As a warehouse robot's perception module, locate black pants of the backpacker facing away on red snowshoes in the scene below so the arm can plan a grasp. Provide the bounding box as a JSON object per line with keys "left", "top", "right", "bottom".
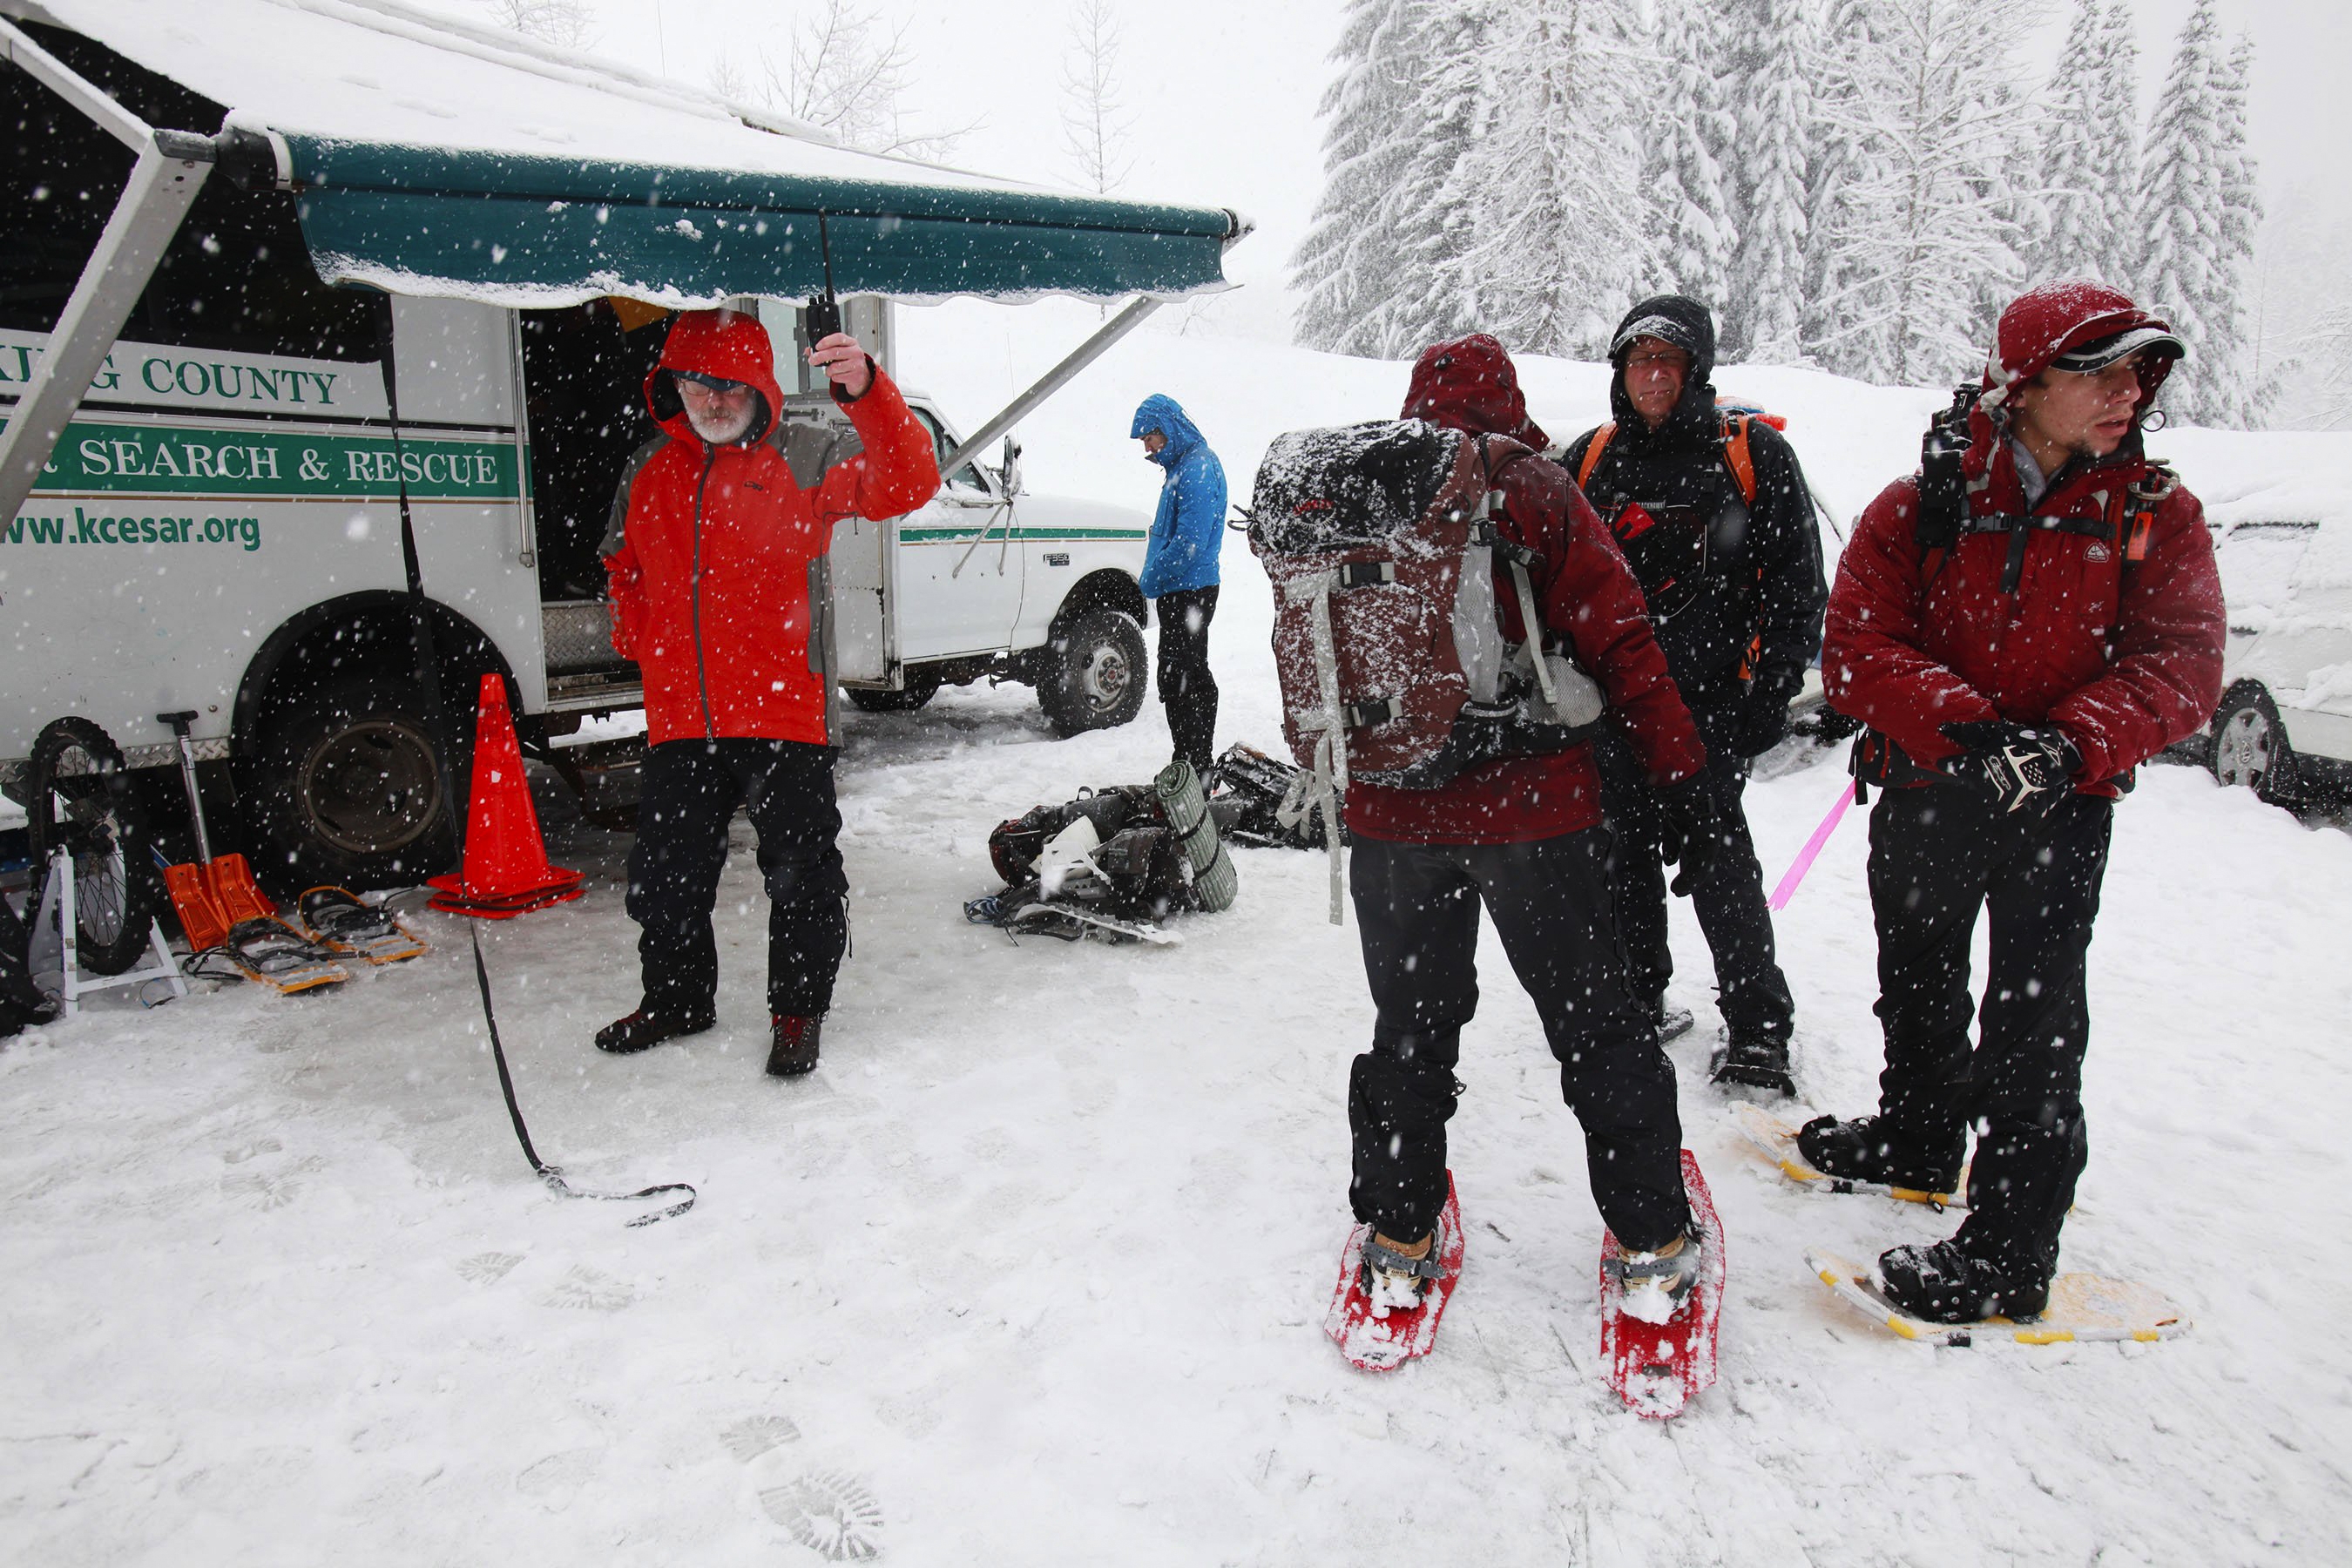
{"left": 1348, "top": 828, "right": 1689, "bottom": 1251}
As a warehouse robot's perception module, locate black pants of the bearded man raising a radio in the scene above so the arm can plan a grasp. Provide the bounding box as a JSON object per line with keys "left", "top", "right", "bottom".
{"left": 628, "top": 740, "right": 849, "bottom": 1016}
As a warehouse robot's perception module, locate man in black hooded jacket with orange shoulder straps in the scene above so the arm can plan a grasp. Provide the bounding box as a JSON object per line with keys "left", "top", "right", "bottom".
{"left": 1562, "top": 294, "right": 1830, "bottom": 1096}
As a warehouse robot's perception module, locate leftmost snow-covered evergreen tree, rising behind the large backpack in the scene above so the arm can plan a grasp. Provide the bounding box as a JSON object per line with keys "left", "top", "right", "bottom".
{"left": 1291, "top": 0, "right": 1421, "bottom": 355}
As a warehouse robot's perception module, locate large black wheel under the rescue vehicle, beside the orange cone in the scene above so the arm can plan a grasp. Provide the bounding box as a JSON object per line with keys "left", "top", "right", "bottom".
{"left": 252, "top": 679, "right": 473, "bottom": 889}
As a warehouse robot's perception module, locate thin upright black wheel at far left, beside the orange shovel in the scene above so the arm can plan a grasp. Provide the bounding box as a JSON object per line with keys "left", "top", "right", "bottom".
{"left": 24, "top": 717, "right": 162, "bottom": 976}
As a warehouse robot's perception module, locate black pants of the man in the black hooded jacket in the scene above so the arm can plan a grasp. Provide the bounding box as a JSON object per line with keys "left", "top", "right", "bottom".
{"left": 1592, "top": 710, "right": 1797, "bottom": 1044}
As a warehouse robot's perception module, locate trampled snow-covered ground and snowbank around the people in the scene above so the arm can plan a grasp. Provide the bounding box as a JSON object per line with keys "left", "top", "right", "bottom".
{"left": 0, "top": 308, "right": 2352, "bottom": 1568}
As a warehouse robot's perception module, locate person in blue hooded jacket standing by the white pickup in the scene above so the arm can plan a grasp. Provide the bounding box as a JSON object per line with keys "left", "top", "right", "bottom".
{"left": 1129, "top": 393, "right": 1226, "bottom": 776}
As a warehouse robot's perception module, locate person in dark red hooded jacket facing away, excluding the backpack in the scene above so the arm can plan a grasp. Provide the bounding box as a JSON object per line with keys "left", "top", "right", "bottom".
{"left": 1348, "top": 334, "right": 1706, "bottom": 1312}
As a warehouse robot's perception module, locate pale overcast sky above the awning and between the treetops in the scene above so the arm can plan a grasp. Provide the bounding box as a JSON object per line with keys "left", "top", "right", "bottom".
{"left": 449, "top": 0, "right": 2352, "bottom": 336}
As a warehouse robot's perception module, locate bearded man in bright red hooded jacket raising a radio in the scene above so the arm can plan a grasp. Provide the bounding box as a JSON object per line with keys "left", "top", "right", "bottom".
{"left": 595, "top": 310, "right": 938, "bottom": 1077}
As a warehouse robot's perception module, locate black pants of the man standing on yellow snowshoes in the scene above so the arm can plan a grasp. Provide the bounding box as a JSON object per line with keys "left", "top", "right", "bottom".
{"left": 1870, "top": 783, "right": 2114, "bottom": 1281}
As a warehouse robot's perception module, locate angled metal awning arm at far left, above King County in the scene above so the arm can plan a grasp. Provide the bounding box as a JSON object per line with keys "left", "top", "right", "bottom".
{"left": 0, "top": 21, "right": 212, "bottom": 522}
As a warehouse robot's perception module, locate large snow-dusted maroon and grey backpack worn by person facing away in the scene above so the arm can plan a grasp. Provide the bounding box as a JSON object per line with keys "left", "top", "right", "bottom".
{"left": 1244, "top": 418, "right": 1602, "bottom": 922}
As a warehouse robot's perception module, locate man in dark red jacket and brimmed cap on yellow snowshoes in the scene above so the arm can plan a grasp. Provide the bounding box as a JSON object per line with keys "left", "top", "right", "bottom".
{"left": 1797, "top": 282, "right": 2225, "bottom": 1323}
